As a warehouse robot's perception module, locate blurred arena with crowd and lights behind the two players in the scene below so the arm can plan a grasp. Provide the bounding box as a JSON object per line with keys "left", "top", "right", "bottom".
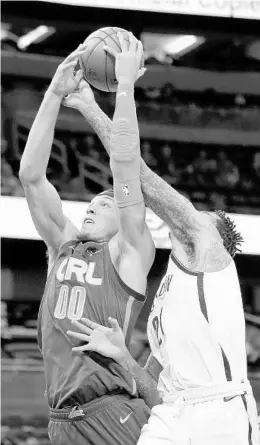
{"left": 1, "top": 0, "right": 260, "bottom": 445}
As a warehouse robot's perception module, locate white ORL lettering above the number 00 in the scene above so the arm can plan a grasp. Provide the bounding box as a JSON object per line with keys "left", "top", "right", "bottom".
{"left": 56, "top": 257, "right": 102, "bottom": 286}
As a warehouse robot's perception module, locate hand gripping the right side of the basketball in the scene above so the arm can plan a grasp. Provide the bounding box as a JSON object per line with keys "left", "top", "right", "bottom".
{"left": 104, "top": 32, "right": 146, "bottom": 83}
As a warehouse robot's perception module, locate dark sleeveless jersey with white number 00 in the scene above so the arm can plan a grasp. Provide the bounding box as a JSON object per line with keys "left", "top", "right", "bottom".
{"left": 38, "top": 241, "right": 145, "bottom": 408}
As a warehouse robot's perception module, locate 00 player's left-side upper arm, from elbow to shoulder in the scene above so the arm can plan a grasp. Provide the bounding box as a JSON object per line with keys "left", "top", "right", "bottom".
{"left": 23, "top": 177, "right": 77, "bottom": 251}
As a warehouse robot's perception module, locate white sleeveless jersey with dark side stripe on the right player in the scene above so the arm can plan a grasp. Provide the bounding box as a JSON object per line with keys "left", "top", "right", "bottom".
{"left": 148, "top": 254, "right": 247, "bottom": 395}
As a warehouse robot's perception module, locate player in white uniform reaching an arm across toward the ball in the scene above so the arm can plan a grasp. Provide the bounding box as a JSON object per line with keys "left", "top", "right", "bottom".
{"left": 66, "top": 40, "right": 259, "bottom": 445}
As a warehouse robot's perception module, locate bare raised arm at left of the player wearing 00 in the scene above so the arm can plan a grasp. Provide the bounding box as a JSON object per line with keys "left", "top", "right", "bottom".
{"left": 19, "top": 45, "right": 85, "bottom": 260}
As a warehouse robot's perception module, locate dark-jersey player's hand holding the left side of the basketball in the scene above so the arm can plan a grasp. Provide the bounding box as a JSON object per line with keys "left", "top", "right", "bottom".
{"left": 48, "top": 44, "right": 87, "bottom": 97}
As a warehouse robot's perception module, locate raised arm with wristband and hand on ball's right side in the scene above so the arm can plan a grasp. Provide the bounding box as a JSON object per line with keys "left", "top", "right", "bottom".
{"left": 105, "top": 33, "right": 154, "bottom": 278}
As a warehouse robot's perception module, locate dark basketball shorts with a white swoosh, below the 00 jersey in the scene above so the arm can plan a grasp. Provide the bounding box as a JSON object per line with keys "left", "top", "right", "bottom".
{"left": 49, "top": 395, "right": 151, "bottom": 445}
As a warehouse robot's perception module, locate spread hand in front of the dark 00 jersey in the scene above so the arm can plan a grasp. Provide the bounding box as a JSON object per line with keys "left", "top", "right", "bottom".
{"left": 67, "top": 317, "right": 127, "bottom": 361}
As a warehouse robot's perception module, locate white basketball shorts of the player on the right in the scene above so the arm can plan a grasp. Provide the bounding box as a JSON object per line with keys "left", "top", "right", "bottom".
{"left": 137, "top": 396, "right": 259, "bottom": 445}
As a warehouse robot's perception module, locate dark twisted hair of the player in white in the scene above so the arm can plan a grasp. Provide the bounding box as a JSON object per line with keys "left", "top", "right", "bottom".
{"left": 214, "top": 210, "right": 244, "bottom": 258}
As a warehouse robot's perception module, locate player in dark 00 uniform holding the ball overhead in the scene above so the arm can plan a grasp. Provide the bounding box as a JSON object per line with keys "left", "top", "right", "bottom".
{"left": 18, "top": 37, "right": 158, "bottom": 445}
